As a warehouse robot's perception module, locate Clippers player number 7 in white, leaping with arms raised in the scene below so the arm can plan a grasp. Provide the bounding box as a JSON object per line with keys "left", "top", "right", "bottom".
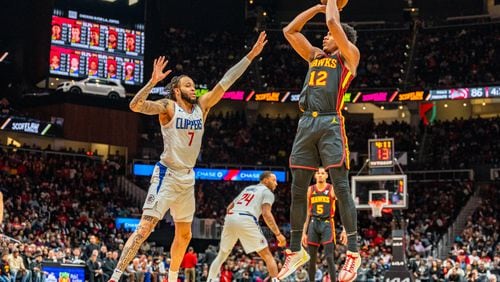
{"left": 110, "top": 32, "right": 267, "bottom": 282}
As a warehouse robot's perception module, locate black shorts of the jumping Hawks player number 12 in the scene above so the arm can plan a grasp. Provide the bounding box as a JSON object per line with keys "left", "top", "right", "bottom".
{"left": 290, "top": 114, "right": 349, "bottom": 170}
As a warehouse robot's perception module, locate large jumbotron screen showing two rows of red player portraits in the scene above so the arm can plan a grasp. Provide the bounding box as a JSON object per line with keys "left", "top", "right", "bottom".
{"left": 49, "top": 10, "right": 144, "bottom": 85}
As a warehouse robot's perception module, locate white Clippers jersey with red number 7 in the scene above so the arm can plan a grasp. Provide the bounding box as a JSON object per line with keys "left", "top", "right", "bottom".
{"left": 160, "top": 102, "right": 204, "bottom": 169}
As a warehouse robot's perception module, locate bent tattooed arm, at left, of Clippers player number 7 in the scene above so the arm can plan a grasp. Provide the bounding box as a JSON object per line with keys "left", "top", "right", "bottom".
{"left": 129, "top": 56, "right": 172, "bottom": 115}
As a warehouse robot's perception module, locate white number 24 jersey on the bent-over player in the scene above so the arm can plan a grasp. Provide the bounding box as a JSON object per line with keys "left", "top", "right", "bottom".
{"left": 233, "top": 183, "right": 274, "bottom": 219}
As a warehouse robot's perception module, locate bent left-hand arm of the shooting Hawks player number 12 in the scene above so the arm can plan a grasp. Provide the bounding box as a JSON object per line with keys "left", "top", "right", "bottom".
{"left": 283, "top": 5, "right": 325, "bottom": 62}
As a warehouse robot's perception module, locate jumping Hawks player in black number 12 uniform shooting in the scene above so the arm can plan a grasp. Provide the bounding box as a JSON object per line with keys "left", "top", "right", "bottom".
{"left": 279, "top": 0, "right": 361, "bottom": 281}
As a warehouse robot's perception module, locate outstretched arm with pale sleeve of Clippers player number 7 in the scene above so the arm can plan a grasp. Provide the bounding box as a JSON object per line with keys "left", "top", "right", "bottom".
{"left": 199, "top": 31, "right": 267, "bottom": 112}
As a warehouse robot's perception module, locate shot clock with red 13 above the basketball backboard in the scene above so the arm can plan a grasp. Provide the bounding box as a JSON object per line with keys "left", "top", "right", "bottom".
{"left": 368, "top": 138, "right": 394, "bottom": 168}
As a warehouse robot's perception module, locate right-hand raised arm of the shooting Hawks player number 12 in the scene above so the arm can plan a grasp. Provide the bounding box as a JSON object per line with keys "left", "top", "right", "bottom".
{"left": 326, "top": 0, "right": 360, "bottom": 75}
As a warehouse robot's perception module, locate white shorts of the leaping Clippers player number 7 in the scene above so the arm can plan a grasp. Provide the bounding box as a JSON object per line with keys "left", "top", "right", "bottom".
{"left": 143, "top": 162, "right": 195, "bottom": 222}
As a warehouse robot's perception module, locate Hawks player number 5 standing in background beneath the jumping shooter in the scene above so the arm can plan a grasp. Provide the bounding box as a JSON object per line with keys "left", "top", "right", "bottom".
{"left": 302, "top": 167, "right": 347, "bottom": 281}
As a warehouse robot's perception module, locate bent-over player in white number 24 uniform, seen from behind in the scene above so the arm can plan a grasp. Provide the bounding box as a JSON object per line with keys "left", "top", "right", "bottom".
{"left": 208, "top": 171, "right": 286, "bottom": 282}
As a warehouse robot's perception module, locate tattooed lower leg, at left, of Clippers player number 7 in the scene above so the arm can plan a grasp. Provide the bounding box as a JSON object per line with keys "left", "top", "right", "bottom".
{"left": 116, "top": 215, "right": 158, "bottom": 272}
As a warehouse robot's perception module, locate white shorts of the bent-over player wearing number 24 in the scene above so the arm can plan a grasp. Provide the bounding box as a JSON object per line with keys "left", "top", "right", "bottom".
{"left": 220, "top": 211, "right": 267, "bottom": 254}
